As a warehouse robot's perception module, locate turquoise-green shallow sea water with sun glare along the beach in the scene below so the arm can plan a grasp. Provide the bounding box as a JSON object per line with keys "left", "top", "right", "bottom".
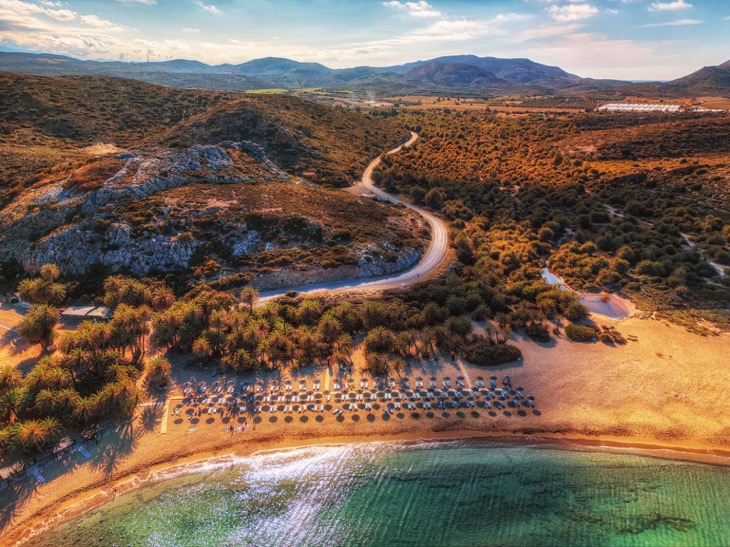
{"left": 31, "top": 441, "right": 730, "bottom": 547}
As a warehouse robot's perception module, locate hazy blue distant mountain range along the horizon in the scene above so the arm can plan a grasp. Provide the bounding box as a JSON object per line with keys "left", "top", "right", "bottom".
{"left": 0, "top": 52, "right": 730, "bottom": 98}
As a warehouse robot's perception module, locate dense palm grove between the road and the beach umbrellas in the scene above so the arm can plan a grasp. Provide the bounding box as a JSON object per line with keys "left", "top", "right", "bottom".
{"left": 0, "top": 256, "right": 540, "bottom": 450}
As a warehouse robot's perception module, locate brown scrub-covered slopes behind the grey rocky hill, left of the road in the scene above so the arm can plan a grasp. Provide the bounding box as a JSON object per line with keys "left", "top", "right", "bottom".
{"left": 0, "top": 73, "right": 408, "bottom": 200}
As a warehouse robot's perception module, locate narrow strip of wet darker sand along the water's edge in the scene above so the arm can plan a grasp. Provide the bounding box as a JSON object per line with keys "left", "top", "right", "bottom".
{"left": 8, "top": 429, "right": 730, "bottom": 545}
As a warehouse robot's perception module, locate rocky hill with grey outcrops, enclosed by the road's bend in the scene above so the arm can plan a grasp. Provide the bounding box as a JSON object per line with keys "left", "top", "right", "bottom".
{"left": 0, "top": 141, "right": 427, "bottom": 292}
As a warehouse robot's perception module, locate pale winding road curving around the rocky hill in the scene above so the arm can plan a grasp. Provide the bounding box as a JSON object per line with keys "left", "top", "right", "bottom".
{"left": 259, "top": 131, "right": 449, "bottom": 303}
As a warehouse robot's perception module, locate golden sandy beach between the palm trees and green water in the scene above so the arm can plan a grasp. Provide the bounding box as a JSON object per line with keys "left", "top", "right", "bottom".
{"left": 0, "top": 310, "right": 730, "bottom": 544}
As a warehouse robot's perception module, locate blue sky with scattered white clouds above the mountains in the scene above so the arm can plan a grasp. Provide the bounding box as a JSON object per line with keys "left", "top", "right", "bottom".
{"left": 0, "top": 0, "right": 730, "bottom": 80}
